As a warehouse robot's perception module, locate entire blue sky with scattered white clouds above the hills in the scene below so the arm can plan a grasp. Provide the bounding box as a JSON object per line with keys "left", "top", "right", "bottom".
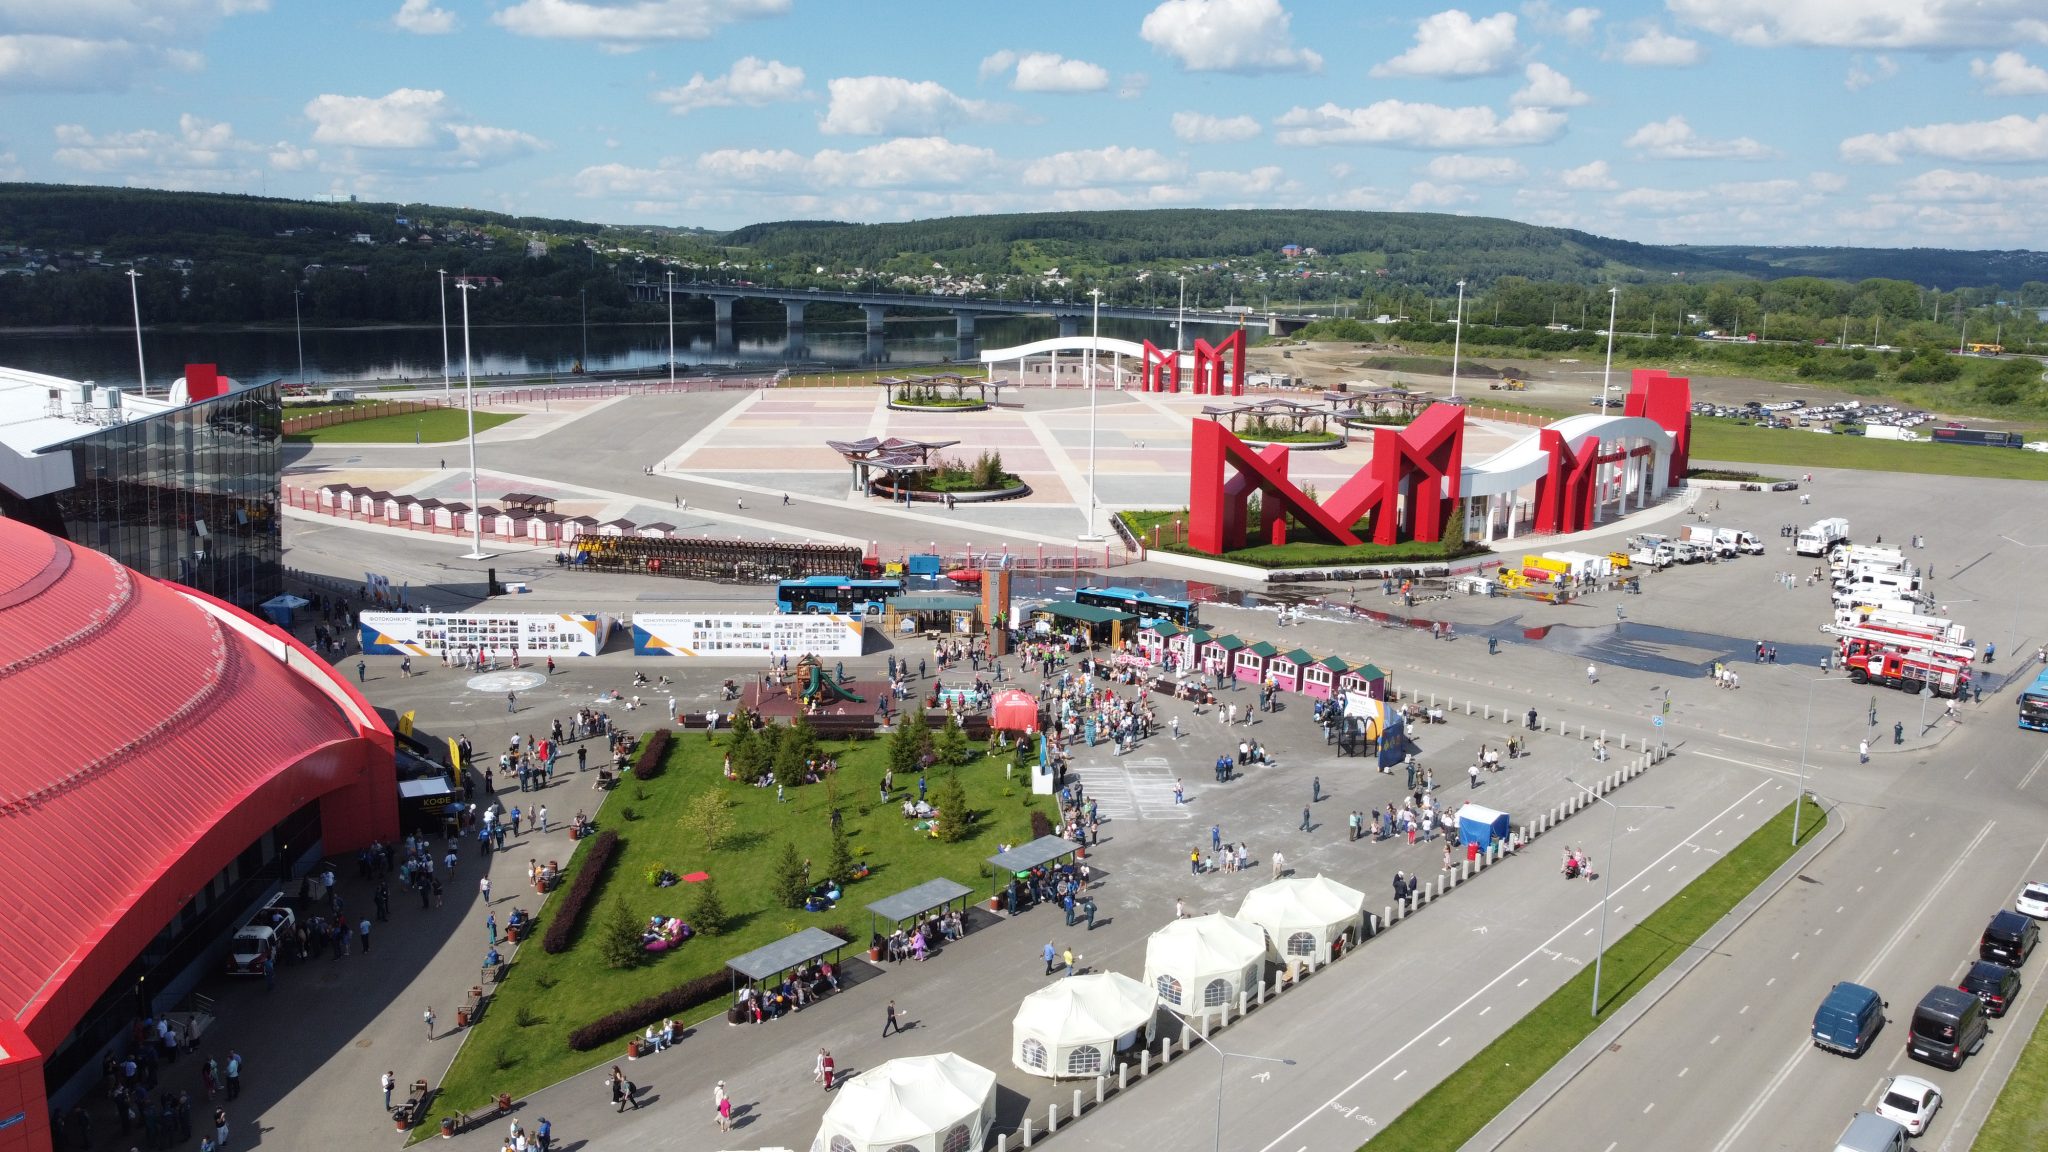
{"left": 0, "top": 0, "right": 2048, "bottom": 248}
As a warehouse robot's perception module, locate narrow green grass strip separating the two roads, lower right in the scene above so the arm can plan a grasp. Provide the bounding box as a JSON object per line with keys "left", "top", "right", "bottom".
{"left": 1366, "top": 787, "right": 1826, "bottom": 1152}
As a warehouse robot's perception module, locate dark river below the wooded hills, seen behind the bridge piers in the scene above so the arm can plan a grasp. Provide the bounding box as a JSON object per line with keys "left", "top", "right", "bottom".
{"left": 0, "top": 316, "right": 1212, "bottom": 387}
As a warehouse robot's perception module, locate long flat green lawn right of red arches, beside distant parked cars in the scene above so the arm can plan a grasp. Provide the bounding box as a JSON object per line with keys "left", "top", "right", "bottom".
{"left": 1692, "top": 418, "right": 2048, "bottom": 480}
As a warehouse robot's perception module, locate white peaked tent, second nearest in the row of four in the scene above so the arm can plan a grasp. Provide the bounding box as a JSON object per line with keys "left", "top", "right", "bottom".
{"left": 1010, "top": 972, "right": 1159, "bottom": 1080}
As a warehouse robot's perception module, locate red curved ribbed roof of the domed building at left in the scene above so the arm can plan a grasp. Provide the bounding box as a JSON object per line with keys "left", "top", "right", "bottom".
{"left": 0, "top": 519, "right": 377, "bottom": 1052}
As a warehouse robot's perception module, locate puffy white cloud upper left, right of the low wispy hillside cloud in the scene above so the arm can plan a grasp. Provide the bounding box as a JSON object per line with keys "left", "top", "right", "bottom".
{"left": 305, "top": 88, "right": 545, "bottom": 168}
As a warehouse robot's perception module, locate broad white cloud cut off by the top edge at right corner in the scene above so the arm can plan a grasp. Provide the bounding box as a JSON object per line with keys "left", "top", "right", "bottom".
{"left": 1665, "top": 0, "right": 2048, "bottom": 49}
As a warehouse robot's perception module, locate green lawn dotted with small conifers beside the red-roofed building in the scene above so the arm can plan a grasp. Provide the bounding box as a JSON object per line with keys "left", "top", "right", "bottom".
{"left": 416, "top": 721, "right": 1055, "bottom": 1136}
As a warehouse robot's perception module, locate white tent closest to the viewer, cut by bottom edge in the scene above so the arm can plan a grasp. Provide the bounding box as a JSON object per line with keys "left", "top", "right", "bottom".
{"left": 811, "top": 1052, "right": 995, "bottom": 1152}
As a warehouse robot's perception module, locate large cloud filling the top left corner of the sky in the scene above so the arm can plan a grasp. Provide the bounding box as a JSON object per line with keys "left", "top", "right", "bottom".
{"left": 0, "top": 0, "right": 268, "bottom": 92}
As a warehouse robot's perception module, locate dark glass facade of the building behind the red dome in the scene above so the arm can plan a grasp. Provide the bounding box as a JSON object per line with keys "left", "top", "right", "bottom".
{"left": 23, "top": 383, "right": 285, "bottom": 609}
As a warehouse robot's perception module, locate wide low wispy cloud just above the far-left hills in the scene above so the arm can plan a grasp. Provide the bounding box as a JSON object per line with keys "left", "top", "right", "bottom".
{"left": 49, "top": 113, "right": 313, "bottom": 189}
